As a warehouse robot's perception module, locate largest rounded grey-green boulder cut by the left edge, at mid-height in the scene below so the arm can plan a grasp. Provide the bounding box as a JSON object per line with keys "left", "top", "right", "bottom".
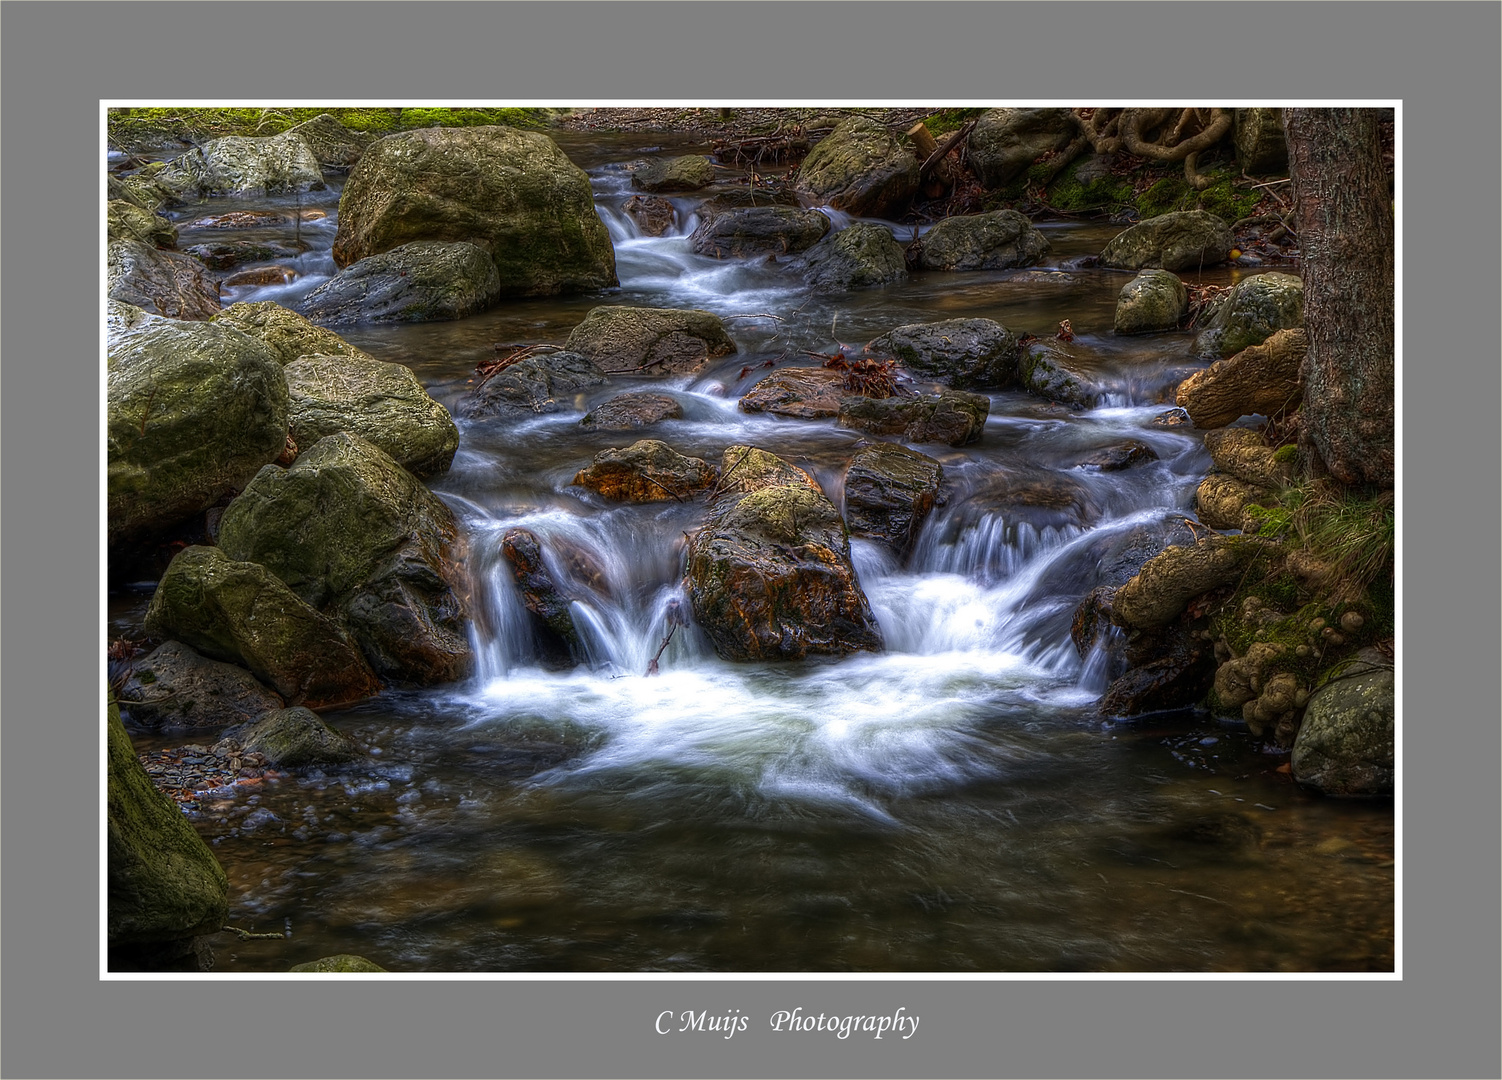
{"left": 105, "top": 318, "right": 288, "bottom": 547}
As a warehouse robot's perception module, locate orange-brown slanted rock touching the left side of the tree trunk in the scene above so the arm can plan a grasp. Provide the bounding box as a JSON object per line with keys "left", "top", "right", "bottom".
{"left": 1175, "top": 330, "right": 1308, "bottom": 428}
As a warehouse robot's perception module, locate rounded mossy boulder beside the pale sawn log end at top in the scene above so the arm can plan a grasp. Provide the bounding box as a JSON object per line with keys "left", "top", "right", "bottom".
{"left": 795, "top": 116, "right": 919, "bottom": 218}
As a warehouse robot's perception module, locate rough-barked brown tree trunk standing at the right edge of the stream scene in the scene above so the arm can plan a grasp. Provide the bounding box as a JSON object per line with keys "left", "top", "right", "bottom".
{"left": 1284, "top": 108, "right": 1395, "bottom": 488}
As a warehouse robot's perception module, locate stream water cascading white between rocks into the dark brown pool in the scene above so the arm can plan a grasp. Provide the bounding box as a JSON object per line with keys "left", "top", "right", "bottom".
{"left": 111, "top": 135, "right": 1395, "bottom": 972}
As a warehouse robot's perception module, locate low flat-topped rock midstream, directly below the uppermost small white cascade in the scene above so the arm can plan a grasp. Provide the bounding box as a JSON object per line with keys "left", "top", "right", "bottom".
{"left": 563, "top": 308, "right": 736, "bottom": 376}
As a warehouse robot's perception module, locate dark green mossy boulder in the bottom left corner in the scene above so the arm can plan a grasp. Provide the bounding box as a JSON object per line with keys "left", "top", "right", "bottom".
{"left": 105, "top": 701, "right": 230, "bottom": 948}
